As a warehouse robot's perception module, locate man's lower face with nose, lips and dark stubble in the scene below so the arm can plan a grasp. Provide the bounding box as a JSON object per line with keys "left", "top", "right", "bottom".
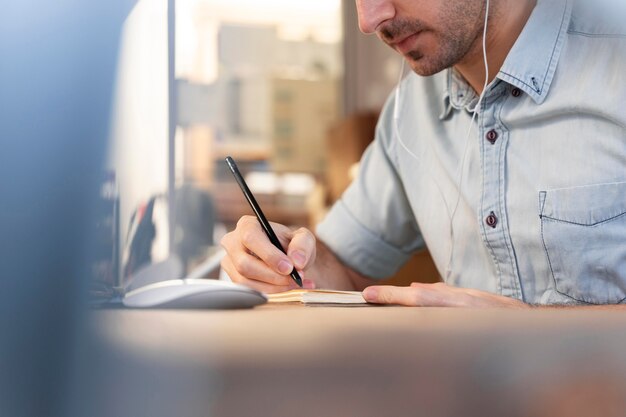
{"left": 356, "top": 0, "right": 485, "bottom": 76}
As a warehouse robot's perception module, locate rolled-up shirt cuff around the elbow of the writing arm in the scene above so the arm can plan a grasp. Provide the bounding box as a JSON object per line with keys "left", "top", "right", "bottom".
{"left": 316, "top": 200, "right": 411, "bottom": 279}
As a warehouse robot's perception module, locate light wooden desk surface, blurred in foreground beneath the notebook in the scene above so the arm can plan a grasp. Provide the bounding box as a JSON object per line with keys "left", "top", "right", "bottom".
{"left": 85, "top": 305, "right": 626, "bottom": 417}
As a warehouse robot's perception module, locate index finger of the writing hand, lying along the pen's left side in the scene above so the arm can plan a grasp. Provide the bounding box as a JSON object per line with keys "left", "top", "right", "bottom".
{"left": 233, "top": 216, "right": 293, "bottom": 275}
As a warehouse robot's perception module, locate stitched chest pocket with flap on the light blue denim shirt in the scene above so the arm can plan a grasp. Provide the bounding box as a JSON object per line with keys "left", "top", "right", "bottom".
{"left": 539, "top": 182, "right": 626, "bottom": 304}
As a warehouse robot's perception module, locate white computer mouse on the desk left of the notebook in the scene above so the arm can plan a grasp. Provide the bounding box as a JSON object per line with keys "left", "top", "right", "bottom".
{"left": 122, "top": 279, "right": 267, "bottom": 309}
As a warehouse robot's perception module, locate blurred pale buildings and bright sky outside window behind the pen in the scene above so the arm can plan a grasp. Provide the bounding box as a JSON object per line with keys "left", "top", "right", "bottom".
{"left": 175, "top": 0, "right": 343, "bottom": 270}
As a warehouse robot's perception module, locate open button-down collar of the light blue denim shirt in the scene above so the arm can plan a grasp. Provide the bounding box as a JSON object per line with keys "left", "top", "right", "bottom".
{"left": 441, "top": 0, "right": 572, "bottom": 109}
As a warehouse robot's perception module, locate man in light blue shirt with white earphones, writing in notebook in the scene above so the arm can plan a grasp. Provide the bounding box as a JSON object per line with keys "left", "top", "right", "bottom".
{"left": 222, "top": 0, "right": 626, "bottom": 308}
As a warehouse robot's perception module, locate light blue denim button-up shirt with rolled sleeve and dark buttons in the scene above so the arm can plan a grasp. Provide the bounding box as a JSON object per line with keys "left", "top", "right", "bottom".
{"left": 317, "top": 0, "right": 626, "bottom": 304}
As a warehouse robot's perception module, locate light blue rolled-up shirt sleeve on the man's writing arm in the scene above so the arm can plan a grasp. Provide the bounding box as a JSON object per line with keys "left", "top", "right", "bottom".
{"left": 316, "top": 92, "right": 425, "bottom": 279}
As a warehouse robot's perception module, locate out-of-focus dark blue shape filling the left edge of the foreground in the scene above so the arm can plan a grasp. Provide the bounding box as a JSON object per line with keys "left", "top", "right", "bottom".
{"left": 0, "top": 0, "right": 128, "bottom": 417}
